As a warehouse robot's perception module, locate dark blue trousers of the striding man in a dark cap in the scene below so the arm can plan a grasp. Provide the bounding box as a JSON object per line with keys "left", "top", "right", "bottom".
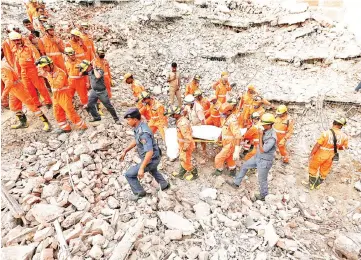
{"left": 125, "top": 157, "right": 168, "bottom": 194}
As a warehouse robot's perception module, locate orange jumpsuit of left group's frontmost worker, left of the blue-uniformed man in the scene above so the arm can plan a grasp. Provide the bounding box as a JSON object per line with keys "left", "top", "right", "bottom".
{"left": 42, "top": 66, "right": 87, "bottom": 130}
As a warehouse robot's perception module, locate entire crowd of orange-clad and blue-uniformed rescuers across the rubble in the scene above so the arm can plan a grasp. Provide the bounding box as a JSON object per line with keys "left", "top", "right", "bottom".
{"left": 1, "top": 0, "right": 348, "bottom": 199}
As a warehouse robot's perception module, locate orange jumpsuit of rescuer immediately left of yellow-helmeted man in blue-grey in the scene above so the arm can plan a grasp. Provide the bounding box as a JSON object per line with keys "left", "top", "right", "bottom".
{"left": 215, "top": 114, "right": 242, "bottom": 170}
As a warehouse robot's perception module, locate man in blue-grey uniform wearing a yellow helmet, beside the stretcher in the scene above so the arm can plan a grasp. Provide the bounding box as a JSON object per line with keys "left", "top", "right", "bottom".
{"left": 226, "top": 113, "right": 277, "bottom": 200}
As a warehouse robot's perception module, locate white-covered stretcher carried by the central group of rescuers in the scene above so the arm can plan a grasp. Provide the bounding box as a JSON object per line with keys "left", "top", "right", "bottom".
{"left": 165, "top": 125, "right": 247, "bottom": 160}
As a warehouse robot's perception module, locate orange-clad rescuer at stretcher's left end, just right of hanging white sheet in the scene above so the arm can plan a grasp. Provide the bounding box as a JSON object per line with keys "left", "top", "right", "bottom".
{"left": 166, "top": 106, "right": 198, "bottom": 181}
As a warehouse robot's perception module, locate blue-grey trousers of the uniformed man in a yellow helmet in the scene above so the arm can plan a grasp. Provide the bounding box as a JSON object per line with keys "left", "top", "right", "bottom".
{"left": 234, "top": 156, "right": 273, "bottom": 197}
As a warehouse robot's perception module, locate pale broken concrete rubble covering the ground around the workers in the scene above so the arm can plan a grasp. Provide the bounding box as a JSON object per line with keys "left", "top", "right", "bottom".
{"left": 1, "top": 0, "right": 361, "bottom": 260}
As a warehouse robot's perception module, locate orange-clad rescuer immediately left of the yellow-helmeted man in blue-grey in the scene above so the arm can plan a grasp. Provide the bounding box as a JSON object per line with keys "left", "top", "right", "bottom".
{"left": 213, "top": 102, "right": 242, "bottom": 176}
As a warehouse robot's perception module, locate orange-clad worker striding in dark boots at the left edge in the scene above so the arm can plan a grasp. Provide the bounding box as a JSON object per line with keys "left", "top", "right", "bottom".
{"left": 1, "top": 49, "right": 50, "bottom": 131}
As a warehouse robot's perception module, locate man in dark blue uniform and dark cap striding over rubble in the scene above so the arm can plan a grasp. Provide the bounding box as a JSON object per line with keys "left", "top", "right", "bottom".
{"left": 120, "top": 108, "right": 169, "bottom": 201}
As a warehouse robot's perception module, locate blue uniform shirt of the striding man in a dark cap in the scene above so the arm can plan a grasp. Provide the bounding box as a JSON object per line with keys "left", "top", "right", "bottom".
{"left": 134, "top": 122, "right": 160, "bottom": 161}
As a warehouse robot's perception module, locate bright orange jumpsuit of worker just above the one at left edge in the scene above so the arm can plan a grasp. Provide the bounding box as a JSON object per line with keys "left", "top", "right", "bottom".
{"left": 15, "top": 45, "right": 52, "bottom": 106}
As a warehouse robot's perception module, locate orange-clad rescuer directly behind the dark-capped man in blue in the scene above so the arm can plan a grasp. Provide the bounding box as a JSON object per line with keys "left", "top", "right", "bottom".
{"left": 139, "top": 91, "right": 168, "bottom": 142}
